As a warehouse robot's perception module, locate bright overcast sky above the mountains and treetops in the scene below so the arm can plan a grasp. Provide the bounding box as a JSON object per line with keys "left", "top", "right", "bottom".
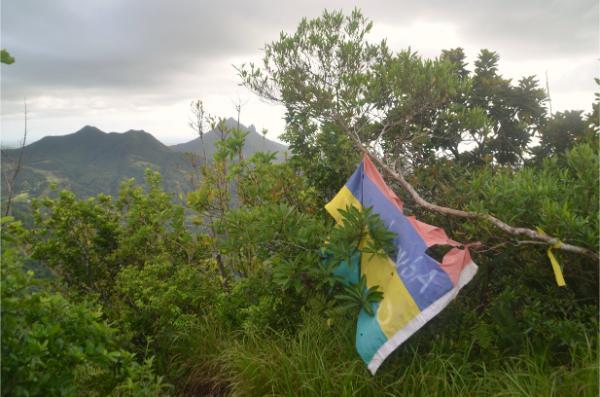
{"left": 0, "top": 0, "right": 599, "bottom": 144}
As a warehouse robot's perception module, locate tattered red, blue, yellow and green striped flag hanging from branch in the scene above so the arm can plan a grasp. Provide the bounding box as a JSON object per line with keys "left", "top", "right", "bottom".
{"left": 325, "top": 155, "right": 477, "bottom": 374}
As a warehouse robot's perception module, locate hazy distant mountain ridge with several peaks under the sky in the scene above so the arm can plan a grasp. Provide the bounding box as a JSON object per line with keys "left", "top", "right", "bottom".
{"left": 1, "top": 119, "right": 287, "bottom": 210}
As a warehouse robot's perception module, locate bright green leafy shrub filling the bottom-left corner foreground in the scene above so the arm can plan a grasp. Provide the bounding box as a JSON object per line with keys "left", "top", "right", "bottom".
{"left": 2, "top": 232, "right": 168, "bottom": 396}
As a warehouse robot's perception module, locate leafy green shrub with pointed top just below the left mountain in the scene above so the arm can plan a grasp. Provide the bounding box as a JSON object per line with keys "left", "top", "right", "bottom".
{"left": 31, "top": 170, "right": 206, "bottom": 299}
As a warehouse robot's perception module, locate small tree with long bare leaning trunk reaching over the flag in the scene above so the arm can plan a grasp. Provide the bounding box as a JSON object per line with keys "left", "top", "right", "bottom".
{"left": 238, "top": 10, "right": 597, "bottom": 258}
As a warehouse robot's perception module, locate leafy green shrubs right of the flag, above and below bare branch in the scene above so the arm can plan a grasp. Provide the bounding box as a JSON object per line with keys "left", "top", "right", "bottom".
{"left": 404, "top": 144, "right": 599, "bottom": 374}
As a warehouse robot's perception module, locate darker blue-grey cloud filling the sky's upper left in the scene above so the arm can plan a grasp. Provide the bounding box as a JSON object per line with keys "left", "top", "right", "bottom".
{"left": 2, "top": 0, "right": 264, "bottom": 91}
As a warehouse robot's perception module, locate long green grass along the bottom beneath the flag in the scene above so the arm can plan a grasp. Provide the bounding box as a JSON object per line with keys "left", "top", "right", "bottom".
{"left": 179, "top": 313, "right": 598, "bottom": 397}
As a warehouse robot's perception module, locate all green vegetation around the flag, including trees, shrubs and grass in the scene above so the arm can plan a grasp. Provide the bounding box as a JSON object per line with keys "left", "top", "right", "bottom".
{"left": 2, "top": 12, "right": 599, "bottom": 396}
